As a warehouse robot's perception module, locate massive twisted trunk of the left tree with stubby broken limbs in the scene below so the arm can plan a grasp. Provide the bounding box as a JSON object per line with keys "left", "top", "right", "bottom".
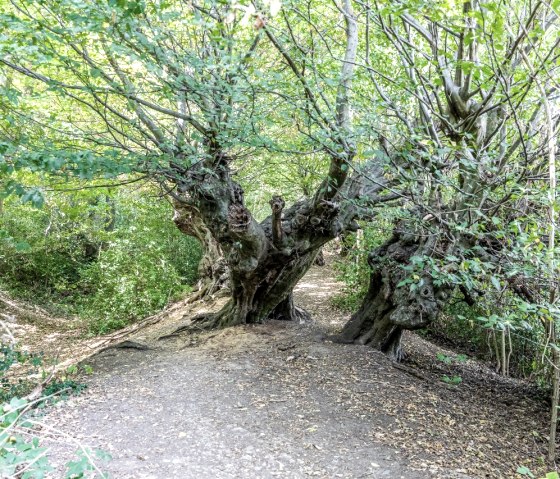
{"left": 176, "top": 152, "right": 358, "bottom": 330}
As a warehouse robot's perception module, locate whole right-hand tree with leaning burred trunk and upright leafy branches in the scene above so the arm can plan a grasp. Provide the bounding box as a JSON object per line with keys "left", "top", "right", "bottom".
{"left": 338, "top": 1, "right": 558, "bottom": 358}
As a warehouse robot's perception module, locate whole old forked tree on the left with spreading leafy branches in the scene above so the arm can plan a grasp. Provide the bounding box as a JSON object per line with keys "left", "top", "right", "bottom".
{"left": 0, "top": 0, "right": 374, "bottom": 327}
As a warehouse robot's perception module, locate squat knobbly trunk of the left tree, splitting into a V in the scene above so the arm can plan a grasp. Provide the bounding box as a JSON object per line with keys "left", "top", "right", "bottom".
{"left": 186, "top": 182, "right": 353, "bottom": 328}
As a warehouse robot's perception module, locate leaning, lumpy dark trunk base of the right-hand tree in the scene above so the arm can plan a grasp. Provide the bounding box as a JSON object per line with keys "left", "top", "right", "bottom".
{"left": 334, "top": 224, "right": 447, "bottom": 360}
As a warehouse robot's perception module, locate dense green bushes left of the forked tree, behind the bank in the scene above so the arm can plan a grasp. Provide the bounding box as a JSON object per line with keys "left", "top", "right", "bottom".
{"left": 0, "top": 182, "right": 201, "bottom": 334}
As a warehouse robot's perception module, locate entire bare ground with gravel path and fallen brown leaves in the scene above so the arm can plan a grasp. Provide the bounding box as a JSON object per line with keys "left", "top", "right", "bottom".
{"left": 3, "top": 260, "right": 553, "bottom": 479}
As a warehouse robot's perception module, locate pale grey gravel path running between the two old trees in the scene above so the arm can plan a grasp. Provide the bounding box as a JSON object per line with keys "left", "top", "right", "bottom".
{"left": 40, "top": 269, "right": 434, "bottom": 479}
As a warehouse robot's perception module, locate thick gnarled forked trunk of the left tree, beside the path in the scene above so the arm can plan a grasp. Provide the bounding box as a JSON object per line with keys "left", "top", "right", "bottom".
{"left": 174, "top": 180, "right": 328, "bottom": 329}
